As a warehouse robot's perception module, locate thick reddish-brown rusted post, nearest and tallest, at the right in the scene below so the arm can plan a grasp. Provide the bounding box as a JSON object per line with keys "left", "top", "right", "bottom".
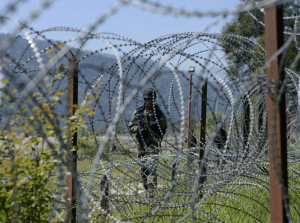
{"left": 265, "top": 0, "right": 288, "bottom": 223}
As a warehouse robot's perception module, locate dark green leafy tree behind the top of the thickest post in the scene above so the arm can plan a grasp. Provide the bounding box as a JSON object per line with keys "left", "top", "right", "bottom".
{"left": 222, "top": 0, "right": 300, "bottom": 75}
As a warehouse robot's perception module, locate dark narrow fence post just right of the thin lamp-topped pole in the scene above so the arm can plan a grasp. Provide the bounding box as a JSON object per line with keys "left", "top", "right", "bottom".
{"left": 199, "top": 78, "right": 208, "bottom": 198}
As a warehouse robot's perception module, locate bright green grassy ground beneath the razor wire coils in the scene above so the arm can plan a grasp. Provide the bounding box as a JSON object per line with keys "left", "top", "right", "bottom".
{"left": 73, "top": 133, "right": 300, "bottom": 223}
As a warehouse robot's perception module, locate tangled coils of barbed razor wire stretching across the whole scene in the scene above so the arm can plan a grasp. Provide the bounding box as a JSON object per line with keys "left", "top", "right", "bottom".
{"left": 0, "top": 0, "right": 300, "bottom": 222}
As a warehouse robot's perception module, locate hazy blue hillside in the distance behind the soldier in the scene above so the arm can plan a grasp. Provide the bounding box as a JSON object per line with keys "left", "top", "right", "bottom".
{"left": 0, "top": 34, "right": 226, "bottom": 129}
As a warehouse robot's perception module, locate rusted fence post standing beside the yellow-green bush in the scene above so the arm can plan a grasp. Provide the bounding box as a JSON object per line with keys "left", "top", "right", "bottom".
{"left": 67, "top": 51, "right": 78, "bottom": 223}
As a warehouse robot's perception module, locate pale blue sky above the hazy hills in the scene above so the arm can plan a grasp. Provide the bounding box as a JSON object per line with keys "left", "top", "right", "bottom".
{"left": 0, "top": 0, "right": 240, "bottom": 49}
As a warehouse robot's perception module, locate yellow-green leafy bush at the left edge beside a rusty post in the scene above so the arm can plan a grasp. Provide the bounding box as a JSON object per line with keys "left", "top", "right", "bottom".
{"left": 0, "top": 52, "right": 93, "bottom": 222}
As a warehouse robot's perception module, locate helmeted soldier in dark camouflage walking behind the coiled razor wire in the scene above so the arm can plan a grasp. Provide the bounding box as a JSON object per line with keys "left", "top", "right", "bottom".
{"left": 128, "top": 88, "right": 167, "bottom": 198}
